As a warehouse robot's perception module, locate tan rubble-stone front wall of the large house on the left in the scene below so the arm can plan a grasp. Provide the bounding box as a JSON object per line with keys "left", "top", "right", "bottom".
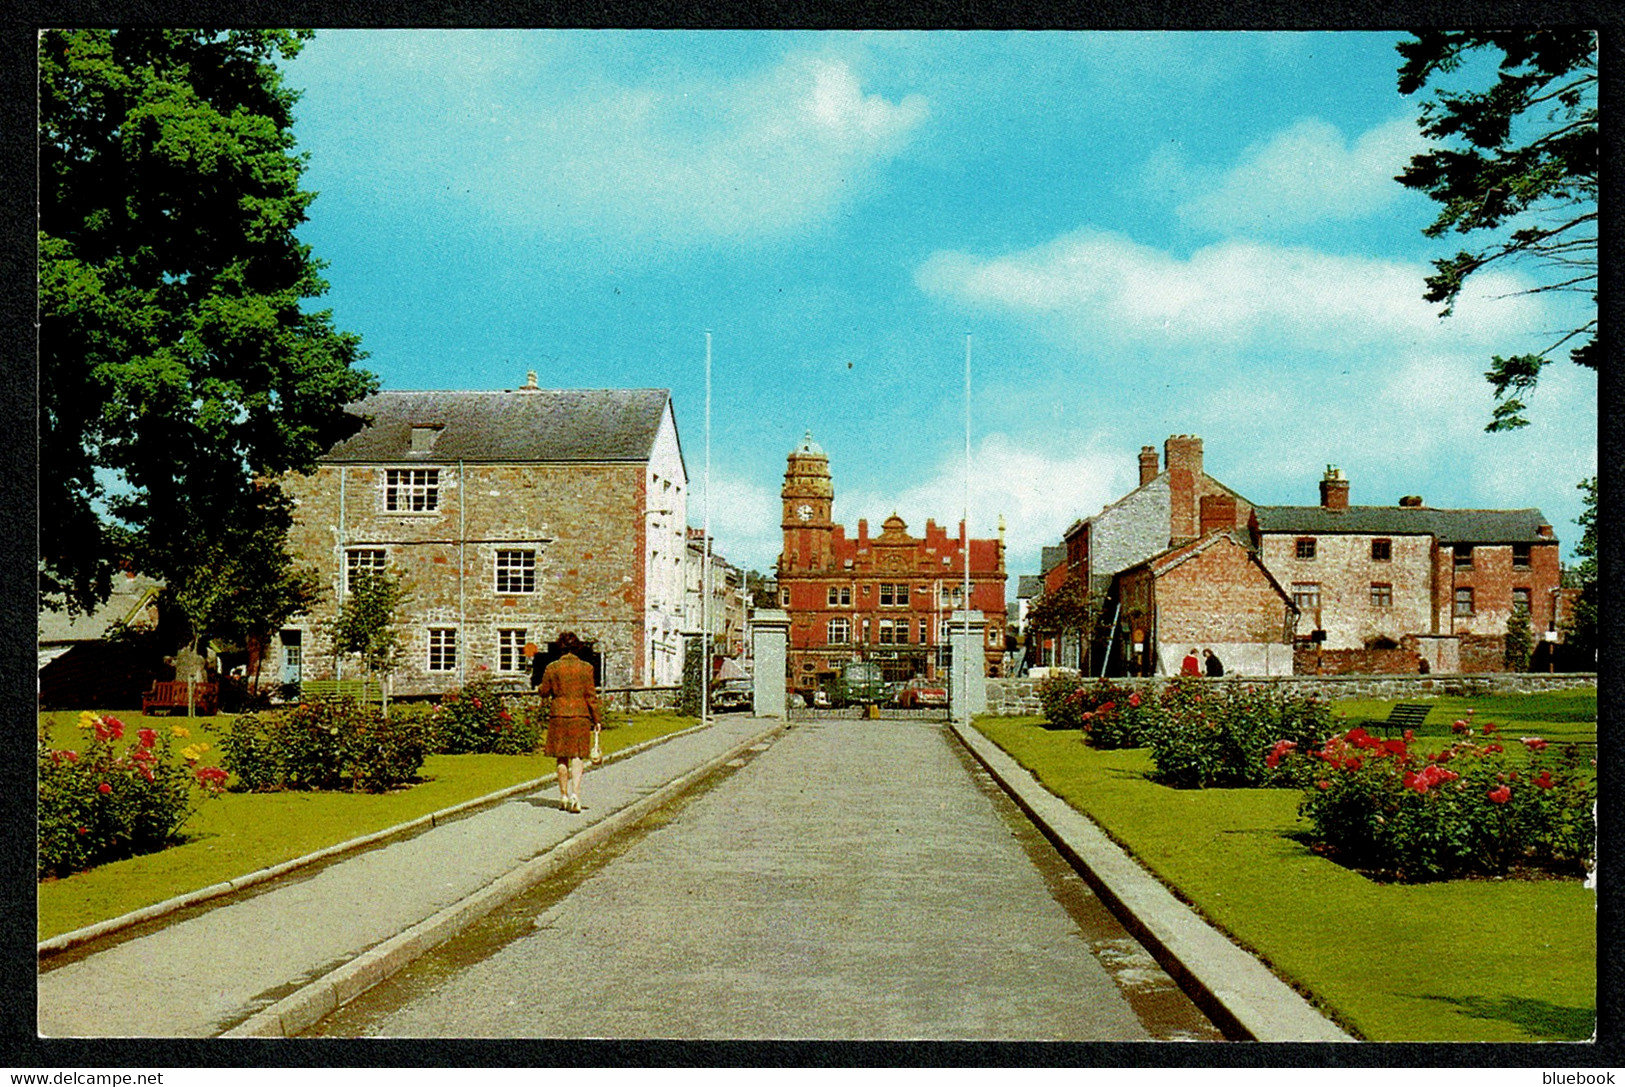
{"left": 282, "top": 463, "right": 647, "bottom": 695}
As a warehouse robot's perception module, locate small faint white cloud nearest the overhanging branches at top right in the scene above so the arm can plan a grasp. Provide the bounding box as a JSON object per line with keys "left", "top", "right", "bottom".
{"left": 1176, "top": 119, "right": 1425, "bottom": 234}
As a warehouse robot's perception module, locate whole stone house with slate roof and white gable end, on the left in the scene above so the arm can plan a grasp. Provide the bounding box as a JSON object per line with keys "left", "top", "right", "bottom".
{"left": 270, "top": 374, "right": 687, "bottom": 695}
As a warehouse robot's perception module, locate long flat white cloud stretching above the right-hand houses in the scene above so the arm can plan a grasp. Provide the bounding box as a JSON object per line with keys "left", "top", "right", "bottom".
{"left": 915, "top": 227, "right": 1537, "bottom": 353}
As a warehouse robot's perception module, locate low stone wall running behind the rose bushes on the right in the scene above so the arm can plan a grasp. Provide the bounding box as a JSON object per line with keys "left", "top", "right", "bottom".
{"left": 988, "top": 673, "right": 1597, "bottom": 717}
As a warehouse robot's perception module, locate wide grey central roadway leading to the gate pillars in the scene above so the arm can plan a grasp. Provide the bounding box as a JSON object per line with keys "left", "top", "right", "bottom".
{"left": 319, "top": 720, "right": 1217, "bottom": 1040}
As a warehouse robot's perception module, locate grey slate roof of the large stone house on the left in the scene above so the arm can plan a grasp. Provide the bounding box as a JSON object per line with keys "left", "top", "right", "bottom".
{"left": 322, "top": 388, "right": 671, "bottom": 465}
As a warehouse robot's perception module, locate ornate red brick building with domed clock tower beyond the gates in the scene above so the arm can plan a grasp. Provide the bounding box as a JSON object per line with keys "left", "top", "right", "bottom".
{"left": 778, "top": 434, "right": 1004, "bottom": 695}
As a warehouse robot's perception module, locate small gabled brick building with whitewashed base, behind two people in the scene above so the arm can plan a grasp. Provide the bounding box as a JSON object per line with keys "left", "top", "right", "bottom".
{"left": 1108, "top": 531, "right": 1297, "bottom": 676}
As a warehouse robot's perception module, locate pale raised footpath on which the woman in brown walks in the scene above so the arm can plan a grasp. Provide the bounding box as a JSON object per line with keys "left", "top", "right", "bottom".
{"left": 39, "top": 715, "right": 775, "bottom": 1037}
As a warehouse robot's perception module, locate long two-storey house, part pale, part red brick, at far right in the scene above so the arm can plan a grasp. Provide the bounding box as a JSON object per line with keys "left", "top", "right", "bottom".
{"left": 1251, "top": 468, "right": 1562, "bottom": 673}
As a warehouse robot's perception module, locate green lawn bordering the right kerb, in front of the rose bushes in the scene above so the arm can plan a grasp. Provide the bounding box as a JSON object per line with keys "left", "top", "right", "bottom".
{"left": 977, "top": 708, "right": 1597, "bottom": 1042}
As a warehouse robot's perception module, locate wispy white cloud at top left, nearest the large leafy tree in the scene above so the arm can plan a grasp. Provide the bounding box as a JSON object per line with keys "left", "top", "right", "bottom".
{"left": 483, "top": 57, "right": 928, "bottom": 245}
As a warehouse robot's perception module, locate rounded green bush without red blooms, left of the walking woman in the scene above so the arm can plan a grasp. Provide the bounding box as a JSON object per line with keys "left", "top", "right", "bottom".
{"left": 221, "top": 699, "right": 432, "bottom": 793}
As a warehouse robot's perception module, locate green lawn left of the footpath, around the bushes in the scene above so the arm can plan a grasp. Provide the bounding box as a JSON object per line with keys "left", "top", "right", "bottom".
{"left": 37, "top": 713, "right": 697, "bottom": 939}
